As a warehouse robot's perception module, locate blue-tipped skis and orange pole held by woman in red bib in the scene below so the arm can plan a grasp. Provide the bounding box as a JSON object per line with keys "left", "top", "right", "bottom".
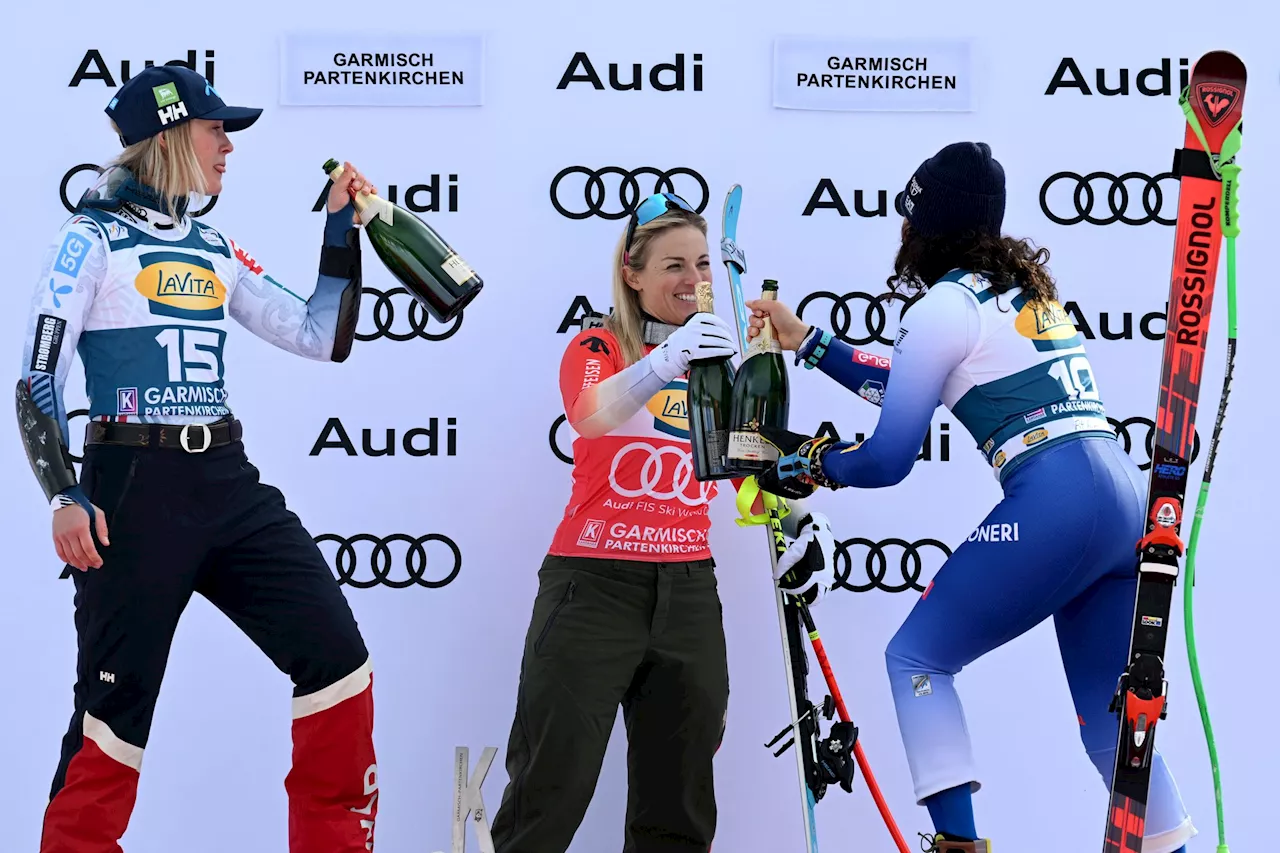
{"left": 721, "top": 184, "right": 909, "bottom": 853}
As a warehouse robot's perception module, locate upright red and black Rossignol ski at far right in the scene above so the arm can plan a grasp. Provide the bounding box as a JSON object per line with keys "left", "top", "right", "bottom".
{"left": 1102, "top": 51, "right": 1245, "bottom": 853}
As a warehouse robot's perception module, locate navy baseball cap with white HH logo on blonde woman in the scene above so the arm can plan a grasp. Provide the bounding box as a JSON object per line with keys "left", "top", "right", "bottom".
{"left": 104, "top": 65, "right": 262, "bottom": 146}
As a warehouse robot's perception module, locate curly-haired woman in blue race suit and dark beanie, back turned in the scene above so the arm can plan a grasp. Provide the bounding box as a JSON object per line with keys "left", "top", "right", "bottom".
{"left": 751, "top": 142, "right": 1196, "bottom": 853}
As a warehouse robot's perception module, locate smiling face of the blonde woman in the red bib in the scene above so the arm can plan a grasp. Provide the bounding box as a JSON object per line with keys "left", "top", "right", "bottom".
{"left": 623, "top": 225, "right": 712, "bottom": 325}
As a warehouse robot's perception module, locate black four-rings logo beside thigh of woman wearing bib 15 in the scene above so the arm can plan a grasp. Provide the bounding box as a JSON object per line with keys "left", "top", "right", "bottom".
{"left": 315, "top": 533, "right": 462, "bottom": 589}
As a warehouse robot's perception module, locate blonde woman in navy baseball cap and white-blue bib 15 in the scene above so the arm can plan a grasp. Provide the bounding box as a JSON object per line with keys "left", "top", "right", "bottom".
{"left": 10, "top": 65, "right": 378, "bottom": 853}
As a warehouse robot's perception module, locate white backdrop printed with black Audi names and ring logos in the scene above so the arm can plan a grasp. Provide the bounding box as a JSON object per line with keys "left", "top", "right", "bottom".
{"left": 0, "top": 0, "right": 1280, "bottom": 853}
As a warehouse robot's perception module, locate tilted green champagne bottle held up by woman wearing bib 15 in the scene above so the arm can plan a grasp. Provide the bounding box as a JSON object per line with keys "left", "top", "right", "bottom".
{"left": 324, "top": 159, "right": 484, "bottom": 323}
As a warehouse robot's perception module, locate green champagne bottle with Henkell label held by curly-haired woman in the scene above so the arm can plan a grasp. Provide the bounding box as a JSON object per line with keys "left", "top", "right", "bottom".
{"left": 728, "top": 278, "right": 791, "bottom": 476}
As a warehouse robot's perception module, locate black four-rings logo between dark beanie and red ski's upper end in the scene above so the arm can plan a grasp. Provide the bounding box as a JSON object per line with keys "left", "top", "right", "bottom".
{"left": 1041, "top": 172, "right": 1178, "bottom": 225}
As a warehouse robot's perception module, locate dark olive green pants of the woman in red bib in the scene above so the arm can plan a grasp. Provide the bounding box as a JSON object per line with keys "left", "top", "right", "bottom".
{"left": 492, "top": 556, "right": 728, "bottom": 853}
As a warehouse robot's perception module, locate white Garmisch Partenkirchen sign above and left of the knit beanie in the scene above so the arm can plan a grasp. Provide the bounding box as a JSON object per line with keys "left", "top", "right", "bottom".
{"left": 773, "top": 36, "right": 973, "bottom": 111}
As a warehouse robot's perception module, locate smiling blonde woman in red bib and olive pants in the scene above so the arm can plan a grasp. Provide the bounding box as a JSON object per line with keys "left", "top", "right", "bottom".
{"left": 492, "top": 193, "right": 835, "bottom": 853}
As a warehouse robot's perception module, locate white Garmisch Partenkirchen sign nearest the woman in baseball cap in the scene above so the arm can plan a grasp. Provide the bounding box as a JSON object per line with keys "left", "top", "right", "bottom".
{"left": 280, "top": 32, "right": 484, "bottom": 106}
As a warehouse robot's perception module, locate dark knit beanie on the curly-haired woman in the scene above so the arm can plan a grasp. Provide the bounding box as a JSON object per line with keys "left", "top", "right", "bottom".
{"left": 893, "top": 142, "right": 1005, "bottom": 237}
